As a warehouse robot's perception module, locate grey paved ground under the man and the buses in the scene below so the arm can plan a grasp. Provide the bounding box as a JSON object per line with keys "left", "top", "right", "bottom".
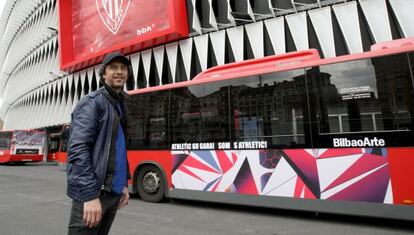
{"left": 0, "top": 163, "right": 414, "bottom": 235}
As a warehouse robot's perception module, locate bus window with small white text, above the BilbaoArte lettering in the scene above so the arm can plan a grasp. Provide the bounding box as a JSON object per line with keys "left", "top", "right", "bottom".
{"left": 309, "top": 54, "right": 414, "bottom": 145}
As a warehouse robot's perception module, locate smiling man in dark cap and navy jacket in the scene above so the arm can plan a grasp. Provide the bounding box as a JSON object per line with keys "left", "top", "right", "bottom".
{"left": 67, "top": 52, "right": 132, "bottom": 235}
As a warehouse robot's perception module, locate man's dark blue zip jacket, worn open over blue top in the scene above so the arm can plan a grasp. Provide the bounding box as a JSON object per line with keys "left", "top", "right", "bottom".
{"left": 67, "top": 87, "right": 129, "bottom": 202}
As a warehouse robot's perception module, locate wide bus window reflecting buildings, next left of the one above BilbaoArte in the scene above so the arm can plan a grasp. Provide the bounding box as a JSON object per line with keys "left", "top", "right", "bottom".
{"left": 231, "top": 70, "right": 310, "bottom": 147}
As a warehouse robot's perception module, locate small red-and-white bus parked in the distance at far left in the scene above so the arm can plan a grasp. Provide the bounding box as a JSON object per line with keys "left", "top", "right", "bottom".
{"left": 0, "top": 130, "right": 46, "bottom": 164}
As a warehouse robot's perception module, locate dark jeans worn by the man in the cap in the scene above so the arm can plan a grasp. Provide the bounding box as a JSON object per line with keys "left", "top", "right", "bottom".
{"left": 68, "top": 191, "right": 122, "bottom": 235}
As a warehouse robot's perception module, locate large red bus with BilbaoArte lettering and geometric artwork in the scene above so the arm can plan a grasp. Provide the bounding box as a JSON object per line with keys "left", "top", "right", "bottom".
{"left": 127, "top": 38, "right": 414, "bottom": 220}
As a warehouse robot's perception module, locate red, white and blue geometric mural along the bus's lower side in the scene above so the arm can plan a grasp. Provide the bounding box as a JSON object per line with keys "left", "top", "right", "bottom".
{"left": 172, "top": 148, "right": 392, "bottom": 203}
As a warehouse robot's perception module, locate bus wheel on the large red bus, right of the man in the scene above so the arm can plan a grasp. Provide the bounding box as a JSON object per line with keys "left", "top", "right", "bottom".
{"left": 136, "top": 165, "right": 165, "bottom": 202}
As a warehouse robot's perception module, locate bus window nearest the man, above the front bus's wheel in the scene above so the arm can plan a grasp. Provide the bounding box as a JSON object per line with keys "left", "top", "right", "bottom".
{"left": 126, "top": 91, "right": 169, "bottom": 150}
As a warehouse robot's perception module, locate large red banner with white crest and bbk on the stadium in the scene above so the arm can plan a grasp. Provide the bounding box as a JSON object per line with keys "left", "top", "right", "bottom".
{"left": 59, "top": 0, "right": 188, "bottom": 71}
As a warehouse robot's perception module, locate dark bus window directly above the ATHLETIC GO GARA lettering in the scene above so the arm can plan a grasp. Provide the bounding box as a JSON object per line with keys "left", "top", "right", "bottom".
{"left": 170, "top": 82, "right": 230, "bottom": 143}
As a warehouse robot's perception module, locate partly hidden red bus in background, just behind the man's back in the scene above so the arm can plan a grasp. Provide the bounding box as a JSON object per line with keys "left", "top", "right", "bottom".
{"left": 47, "top": 125, "right": 70, "bottom": 166}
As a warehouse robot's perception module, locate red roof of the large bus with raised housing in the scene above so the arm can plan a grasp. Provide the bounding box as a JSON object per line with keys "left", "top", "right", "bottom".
{"left": 128, "top": 37, "right": 414, "bottom": 95}
